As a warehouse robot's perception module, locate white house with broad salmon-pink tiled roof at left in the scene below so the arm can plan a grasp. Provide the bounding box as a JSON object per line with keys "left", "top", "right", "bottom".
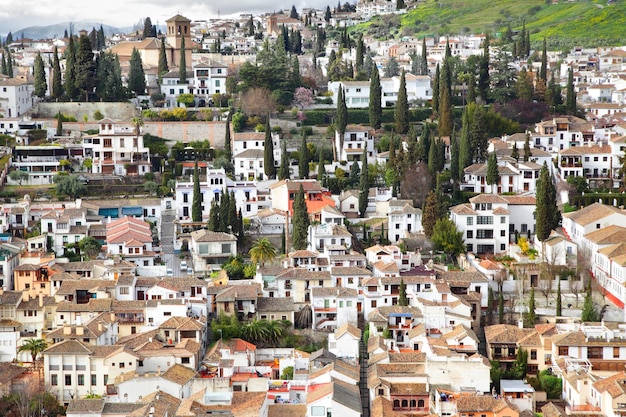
{"left": 106, "top": 217, "right": 155, "bottom": 266}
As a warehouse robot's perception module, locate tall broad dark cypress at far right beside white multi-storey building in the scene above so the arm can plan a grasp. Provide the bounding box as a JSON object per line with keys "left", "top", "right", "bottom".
{"left": 535, "top": 164, "right": 561, "bottom": 242}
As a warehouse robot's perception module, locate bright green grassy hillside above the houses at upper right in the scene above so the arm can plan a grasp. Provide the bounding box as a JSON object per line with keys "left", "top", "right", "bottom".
{"left": 355, "top": 0, "right": 626, "bottom": 48}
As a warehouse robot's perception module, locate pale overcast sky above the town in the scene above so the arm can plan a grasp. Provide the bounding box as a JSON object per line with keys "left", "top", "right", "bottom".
{"left": 0, "top": 0, "right": 334, "bottom": 34}
